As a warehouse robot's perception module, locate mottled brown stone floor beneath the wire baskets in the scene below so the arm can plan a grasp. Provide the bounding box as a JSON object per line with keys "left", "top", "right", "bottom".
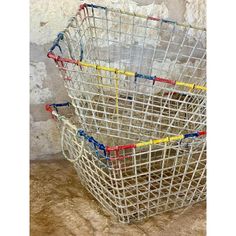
{"left": 30, "top": 156, "right": 206, "bottom": 236}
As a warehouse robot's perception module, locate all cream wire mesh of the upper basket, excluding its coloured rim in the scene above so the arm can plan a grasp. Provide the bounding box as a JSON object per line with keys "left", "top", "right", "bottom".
{"left": 53, "top": 4, "right": 206, "bottom": 145}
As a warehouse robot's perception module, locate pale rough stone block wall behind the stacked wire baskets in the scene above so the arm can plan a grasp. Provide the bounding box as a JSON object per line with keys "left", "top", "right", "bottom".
{"left": 30, "top": 0, "right": 206, "bottom": 159}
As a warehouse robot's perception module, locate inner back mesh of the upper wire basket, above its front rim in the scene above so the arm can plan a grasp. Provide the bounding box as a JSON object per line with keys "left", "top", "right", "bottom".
{"left": 59, "top": 3, "right": 206, "bottom": 83}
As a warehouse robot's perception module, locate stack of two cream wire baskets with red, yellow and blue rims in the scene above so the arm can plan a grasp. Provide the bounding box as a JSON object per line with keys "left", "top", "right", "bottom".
{"left": 47, "top": 4, "right": 206, "bottom": 222}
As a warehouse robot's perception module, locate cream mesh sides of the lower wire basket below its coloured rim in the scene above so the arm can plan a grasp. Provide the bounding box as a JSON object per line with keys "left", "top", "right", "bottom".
{"left": 54, "top": 112, "right": 206, "bottom": 223}
